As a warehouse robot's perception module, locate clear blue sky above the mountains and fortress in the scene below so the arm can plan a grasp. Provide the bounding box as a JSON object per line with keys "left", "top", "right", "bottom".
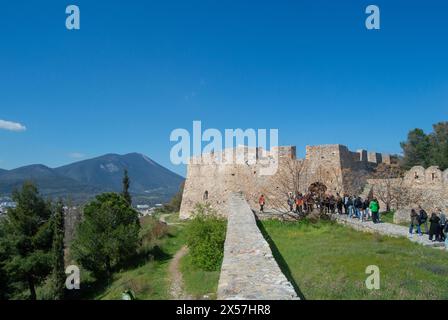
{"left": 0, "top": 0, "right": 448, "bottom": 174}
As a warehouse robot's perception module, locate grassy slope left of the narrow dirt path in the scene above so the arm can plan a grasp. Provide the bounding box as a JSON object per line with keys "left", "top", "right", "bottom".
{"left": 81, "top": 217, "right": 185, "bottom": 300}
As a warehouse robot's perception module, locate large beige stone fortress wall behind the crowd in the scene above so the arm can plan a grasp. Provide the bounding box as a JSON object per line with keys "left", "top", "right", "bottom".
{"left": 180, "top": 145, "right": 390, "bottom": 219}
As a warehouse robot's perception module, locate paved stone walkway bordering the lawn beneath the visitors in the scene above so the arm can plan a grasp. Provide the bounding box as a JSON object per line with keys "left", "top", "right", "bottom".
{"left": 332, "top": 214, "right": 445, "bottom": 248}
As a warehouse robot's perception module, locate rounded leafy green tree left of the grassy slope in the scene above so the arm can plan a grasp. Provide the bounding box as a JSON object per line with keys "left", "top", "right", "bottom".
{"left": 71, "top": 193, "right": 140, "bottom": 279}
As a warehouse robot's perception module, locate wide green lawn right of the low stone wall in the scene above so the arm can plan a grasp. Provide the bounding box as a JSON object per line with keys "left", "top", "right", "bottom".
{"left": 260, "top": 221, "right": 448, "bottom": 299}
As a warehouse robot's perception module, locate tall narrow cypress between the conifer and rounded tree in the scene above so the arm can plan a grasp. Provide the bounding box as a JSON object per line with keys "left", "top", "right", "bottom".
{"left": 51, "top": 201, "right": 66, "bottom": 300}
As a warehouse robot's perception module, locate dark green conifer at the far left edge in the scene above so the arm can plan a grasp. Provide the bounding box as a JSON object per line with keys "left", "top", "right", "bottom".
{"left": 2, "top": 182, "right": 53, "bottom": 300}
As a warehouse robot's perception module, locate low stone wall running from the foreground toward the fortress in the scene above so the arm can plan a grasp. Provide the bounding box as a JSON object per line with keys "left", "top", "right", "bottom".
{"left": 218, "top": 194, "right": 299, "bottom": 300}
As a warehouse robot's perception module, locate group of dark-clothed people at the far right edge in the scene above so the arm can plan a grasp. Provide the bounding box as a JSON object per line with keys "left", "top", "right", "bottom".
{"left": 409, "top": 206, "right": 448, "bottom": 242}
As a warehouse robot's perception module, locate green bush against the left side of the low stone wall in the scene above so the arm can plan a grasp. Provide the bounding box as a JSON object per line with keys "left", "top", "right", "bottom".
{"left": 187, "top": 204, "right": 226, "bottom": 271}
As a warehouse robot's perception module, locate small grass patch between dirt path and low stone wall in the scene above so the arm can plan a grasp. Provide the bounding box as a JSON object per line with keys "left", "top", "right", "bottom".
{"left": 180, "top": 254, "right": 220, "bottom": 299}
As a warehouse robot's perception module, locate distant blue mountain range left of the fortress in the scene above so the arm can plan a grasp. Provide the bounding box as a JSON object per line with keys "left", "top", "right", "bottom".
{"left": 0, "top": 153, "right": 184, "bottom": 204}
